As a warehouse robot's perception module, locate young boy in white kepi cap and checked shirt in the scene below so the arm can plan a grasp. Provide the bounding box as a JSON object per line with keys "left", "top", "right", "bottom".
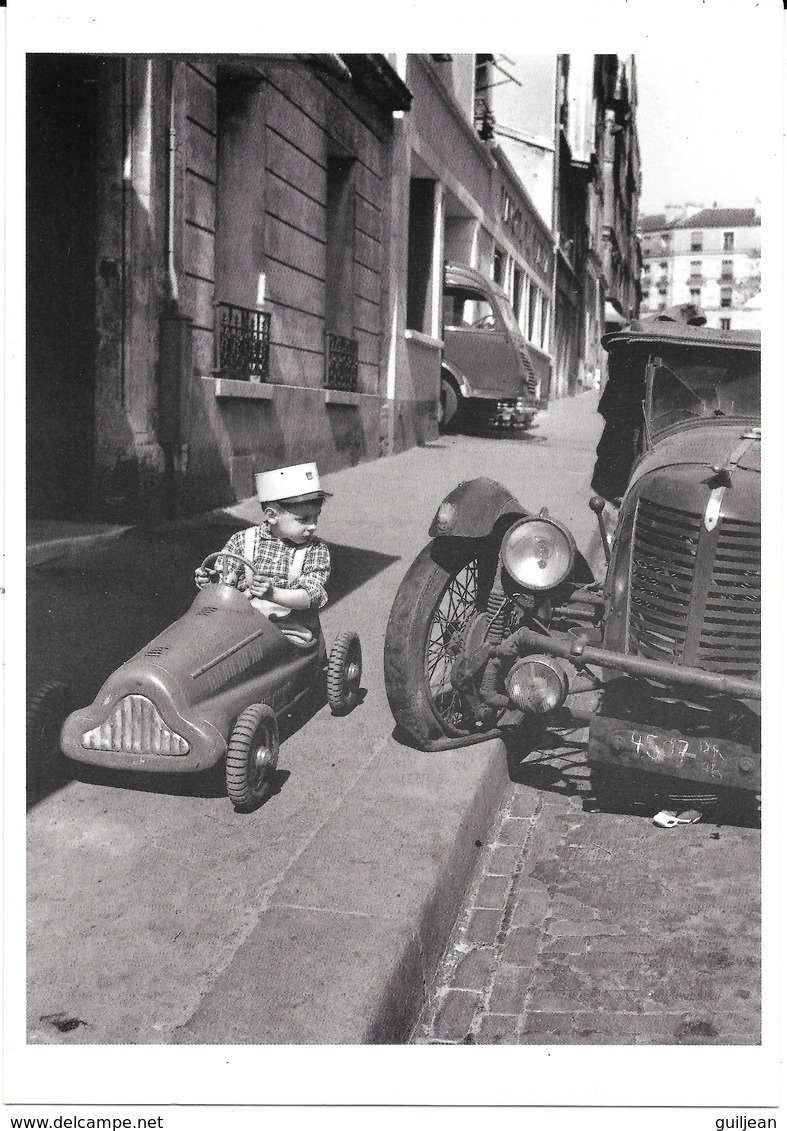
{"left": 194, "top": 464, "right": 330, "bottom": 636}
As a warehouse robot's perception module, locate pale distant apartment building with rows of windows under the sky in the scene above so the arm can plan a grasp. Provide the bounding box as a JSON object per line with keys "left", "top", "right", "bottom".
{"left": 640, "top": 204, "right": 762, "bottom": 330}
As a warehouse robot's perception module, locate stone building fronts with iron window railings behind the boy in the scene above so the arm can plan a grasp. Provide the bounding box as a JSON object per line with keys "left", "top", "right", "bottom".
{"left": 27, "top": 54, "right": 552, "bottom": 521}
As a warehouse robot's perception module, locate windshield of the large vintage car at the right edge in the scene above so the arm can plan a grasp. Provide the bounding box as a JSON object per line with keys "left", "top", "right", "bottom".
{"left": 649, "top": 341, "right": 760, "bottom": 433}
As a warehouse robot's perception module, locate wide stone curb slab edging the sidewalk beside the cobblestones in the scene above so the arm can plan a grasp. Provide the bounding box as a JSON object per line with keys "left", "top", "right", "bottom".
{"left": 172, "top": 739, "right": 509, "bottom": 1045}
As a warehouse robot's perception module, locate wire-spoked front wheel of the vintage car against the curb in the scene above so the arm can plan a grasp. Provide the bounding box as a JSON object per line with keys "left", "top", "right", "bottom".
{"left": 384, "top": 539, "right": 496, "bottom": 750}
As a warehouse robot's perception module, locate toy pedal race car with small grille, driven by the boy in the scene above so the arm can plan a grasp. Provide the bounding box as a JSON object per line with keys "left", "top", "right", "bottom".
{"left": 60, "top": 552, "right": 361, "bottom": 810}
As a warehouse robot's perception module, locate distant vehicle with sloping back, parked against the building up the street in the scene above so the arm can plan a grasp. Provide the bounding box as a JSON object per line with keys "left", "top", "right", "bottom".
{"left": 440, "top": 264, "right": 540, "bottom": 428}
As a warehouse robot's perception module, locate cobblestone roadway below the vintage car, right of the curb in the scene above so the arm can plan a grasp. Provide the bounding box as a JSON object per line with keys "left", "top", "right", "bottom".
{"left": 412, "top": 731, "right": 760, "bottom": 1045}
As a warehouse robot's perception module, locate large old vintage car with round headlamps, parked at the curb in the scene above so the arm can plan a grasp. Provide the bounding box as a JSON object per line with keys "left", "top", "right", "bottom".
{"left": 384, "top": 321, "right": 760, "bottom": 811}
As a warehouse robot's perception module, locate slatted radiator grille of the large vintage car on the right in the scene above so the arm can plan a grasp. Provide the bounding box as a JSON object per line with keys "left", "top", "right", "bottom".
{"left": 629, "top": 500, "right": 760, "bottom": 676}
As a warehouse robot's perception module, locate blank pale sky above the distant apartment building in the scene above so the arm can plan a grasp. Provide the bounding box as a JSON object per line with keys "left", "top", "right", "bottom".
{"left": 635, "top": 50, "right": 779, "bottom": 214}
